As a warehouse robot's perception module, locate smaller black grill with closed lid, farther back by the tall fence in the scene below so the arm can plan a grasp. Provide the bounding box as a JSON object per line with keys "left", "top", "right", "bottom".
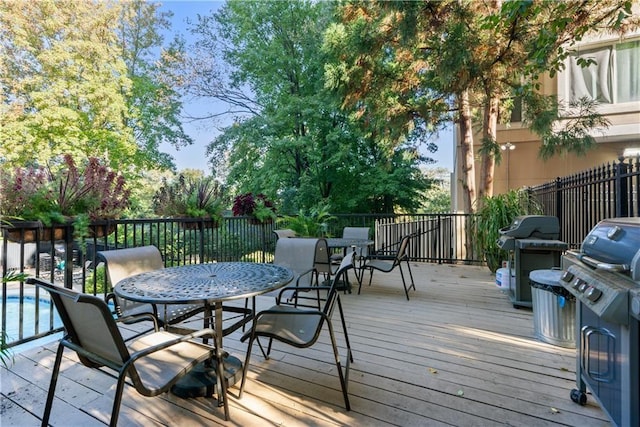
{"left": 497, "top": 215, "right": 568, "bottom": 307}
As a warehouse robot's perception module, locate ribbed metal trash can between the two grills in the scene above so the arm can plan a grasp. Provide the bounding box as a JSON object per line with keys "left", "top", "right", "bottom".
{"left": 529, "top": 270, "right": 576, "bottom": 348}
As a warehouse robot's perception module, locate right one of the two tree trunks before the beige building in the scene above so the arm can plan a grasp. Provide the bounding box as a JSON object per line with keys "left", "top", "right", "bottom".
{"left": 478, "top": 96, "right": 499, "bottom": 200}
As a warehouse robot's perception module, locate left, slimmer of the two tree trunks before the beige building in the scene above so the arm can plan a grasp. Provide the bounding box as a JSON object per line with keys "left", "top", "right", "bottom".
{"left": 458, "top": 90, "right": 476, "bottom": 217}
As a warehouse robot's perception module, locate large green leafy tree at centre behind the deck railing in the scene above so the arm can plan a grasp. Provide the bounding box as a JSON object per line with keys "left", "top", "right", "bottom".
{"left": 190, "top": 1, "right": 427, "bottom": 213}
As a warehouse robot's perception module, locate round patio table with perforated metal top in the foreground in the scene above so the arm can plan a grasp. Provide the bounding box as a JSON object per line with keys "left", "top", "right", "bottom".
{"left": 114, "top": 262, "right": 293, "bottom": 419}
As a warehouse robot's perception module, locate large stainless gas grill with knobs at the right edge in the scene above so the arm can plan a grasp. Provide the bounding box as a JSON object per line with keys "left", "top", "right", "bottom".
{"left": 560, "top": 218, "right": 640, "bottom": 426}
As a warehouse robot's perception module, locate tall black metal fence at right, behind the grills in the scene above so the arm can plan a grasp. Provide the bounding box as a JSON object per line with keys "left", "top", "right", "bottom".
{"left": 531, "top": 158, "right": 640, "bottom": 249}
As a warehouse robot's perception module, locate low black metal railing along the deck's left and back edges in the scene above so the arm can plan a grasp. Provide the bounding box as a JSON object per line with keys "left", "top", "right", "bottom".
{"left": 0, "top": 214, "right": 481, "bottom": 347}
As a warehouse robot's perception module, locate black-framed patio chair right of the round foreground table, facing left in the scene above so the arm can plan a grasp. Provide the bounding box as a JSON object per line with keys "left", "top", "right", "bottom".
{"left": 238, "top": 253, "right": 353, "bottom": 410}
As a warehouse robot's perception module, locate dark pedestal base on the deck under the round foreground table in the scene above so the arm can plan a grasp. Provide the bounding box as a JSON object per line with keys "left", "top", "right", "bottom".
{"left": 171, "top": 356, "right": 242, "bottom": 398}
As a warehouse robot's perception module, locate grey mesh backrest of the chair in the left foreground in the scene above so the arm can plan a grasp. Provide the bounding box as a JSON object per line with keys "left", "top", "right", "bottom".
{"left": 27, "top": 278, "right": 130, "bottom": 369}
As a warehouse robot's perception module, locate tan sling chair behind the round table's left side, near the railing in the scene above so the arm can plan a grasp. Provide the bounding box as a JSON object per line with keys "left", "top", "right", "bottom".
{"left": 96, "top": 245, "right": 204, "bottom": 329}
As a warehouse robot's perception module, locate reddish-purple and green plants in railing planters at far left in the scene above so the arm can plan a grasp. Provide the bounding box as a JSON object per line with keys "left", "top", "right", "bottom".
{"left": 0, "top": 155, "right": 129, "bottom": 241}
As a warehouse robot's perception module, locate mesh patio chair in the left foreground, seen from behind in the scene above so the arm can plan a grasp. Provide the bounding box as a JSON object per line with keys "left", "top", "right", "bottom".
{"left": 27, "top": 278, "right": 215, "bottom": 426}
